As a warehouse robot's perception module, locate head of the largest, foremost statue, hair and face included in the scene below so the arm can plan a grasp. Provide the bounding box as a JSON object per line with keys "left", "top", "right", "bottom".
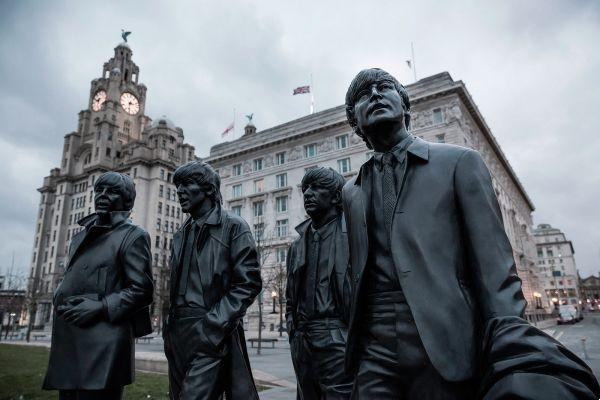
{"left": 346, "top": 68, "right": 410, "bottom": 149}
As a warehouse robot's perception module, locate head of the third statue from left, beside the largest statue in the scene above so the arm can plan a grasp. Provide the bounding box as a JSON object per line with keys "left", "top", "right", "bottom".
{"left": 301, "top": 167, "right": 346, "bottom": 218}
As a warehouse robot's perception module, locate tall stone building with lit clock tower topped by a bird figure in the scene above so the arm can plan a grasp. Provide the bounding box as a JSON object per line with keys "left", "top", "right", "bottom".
{"left": 27, "top": 43, "right": 195, "bottom": 327}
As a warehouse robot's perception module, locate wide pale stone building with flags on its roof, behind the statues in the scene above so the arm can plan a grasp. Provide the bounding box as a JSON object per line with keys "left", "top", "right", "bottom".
{"left": 205, "top": 72, "right": 545, "bottom": 320}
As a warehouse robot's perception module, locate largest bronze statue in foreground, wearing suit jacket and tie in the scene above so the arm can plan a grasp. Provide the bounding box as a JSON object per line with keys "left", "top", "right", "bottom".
{"left": 343, "top": 69, "right": 600, "bottom": 400}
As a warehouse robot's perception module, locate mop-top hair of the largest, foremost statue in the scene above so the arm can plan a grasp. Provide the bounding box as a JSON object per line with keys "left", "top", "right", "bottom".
{"left": 346, "top": 68, "right": 410, "bottom": 149}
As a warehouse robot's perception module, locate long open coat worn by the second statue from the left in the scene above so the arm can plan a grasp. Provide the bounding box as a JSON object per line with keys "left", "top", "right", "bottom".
{"left": 163, "top": 206, "right": 262, "bottom": 400}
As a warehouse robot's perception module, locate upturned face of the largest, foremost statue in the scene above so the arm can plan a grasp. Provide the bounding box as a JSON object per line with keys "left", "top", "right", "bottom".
{"left": 354, "top": 79, "right": 404, "bottom": 135}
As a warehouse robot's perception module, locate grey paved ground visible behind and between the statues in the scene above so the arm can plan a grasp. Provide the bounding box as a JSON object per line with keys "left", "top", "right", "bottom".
{"left": 7, "top": 313, "right": 600, "bottom": 400}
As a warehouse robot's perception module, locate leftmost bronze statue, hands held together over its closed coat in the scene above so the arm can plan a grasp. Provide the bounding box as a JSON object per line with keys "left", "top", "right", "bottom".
{"left": 43, "top": 172, "right": 153, "bottom": 400}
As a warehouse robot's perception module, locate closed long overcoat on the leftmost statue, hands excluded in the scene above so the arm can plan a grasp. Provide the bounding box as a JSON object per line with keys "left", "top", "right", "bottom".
{"left": 43, "top": 212, "right": 154, "bottom": 390}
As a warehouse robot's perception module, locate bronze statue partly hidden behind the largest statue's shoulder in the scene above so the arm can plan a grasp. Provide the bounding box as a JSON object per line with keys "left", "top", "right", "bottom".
{"left": 286, "top": 167, "right": 353, "bottom": 400}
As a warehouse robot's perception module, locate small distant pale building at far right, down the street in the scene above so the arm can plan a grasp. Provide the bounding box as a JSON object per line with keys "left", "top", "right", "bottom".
{"left": 533, "top": 224, "right": 581, "bottom": 305}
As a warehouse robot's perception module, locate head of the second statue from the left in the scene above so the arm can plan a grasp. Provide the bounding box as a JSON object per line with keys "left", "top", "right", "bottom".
{"left": 173, "top": 161, "right": 221, "bottom": 214}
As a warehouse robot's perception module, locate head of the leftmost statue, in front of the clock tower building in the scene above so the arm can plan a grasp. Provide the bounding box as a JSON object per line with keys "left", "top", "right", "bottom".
{"left": 94, "top": 171, "right": 135, "bottom": 214}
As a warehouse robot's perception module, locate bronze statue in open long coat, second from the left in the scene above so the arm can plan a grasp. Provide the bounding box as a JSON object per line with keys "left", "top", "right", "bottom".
{"left": 163, "top": 161, "right": 262, "bottom": 400}
